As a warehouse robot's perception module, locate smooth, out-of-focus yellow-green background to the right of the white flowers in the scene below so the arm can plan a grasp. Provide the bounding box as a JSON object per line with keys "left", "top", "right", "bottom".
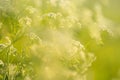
{"left": 76, "top": 0, "right": 120, "bottom": 80}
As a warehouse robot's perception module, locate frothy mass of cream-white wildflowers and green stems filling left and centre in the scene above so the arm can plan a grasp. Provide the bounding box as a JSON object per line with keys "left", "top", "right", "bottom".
{"left": 0, "top": 0, "right": 120, "bottom": 80}
